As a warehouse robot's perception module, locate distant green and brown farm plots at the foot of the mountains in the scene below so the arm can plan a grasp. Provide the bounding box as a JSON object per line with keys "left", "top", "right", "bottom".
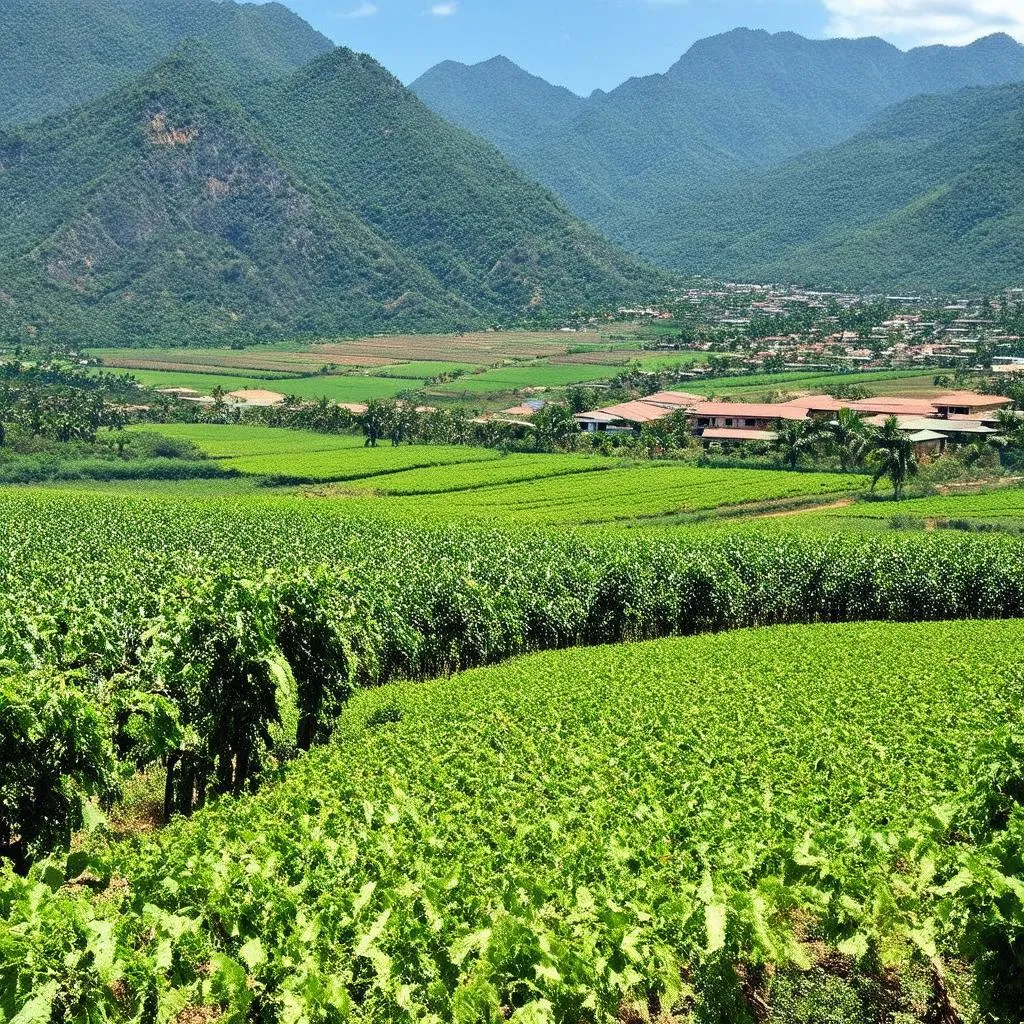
{"left": 90, "top": 327, "right": 935, "bottom": 404}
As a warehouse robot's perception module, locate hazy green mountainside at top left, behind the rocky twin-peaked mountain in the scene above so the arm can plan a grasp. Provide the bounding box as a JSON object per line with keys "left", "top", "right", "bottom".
{"left": 0, "top": 0, "right": 334, "bottom": 127}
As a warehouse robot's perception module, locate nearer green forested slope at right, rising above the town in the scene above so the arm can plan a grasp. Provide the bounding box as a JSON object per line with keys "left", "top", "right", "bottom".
{"left": 636, "top": 85, "right": 1024, "bottom": 292}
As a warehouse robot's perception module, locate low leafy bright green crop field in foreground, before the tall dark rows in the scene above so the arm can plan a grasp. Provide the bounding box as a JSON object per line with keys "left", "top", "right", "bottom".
{"left": 6, "top": 623, "right": 1024, "bottom": 1024}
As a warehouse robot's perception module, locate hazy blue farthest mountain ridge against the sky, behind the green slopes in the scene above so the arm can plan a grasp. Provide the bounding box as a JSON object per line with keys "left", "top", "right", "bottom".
{"left": 413, "top": 29, "right": 1024, "bottom": 237}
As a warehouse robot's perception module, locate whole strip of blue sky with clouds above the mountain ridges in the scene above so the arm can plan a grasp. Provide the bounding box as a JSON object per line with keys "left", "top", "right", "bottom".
{"left": 284, "top": 0, "right": 1024, "bottom": 94}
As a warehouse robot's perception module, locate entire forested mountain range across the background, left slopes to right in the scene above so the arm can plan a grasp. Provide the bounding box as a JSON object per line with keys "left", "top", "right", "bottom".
{"left": 0, "top": 0, "right": 1024, "bottom": 345}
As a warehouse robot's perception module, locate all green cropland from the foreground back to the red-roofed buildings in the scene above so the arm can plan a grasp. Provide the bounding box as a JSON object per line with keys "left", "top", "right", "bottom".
{"left": 6, "top": 372, "right": 1024, "bottom": 1024}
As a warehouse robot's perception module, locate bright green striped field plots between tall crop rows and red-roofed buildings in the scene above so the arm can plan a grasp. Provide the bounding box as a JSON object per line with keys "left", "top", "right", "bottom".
{"left": 125, "top": 425, "right": 866, "bottom": 526}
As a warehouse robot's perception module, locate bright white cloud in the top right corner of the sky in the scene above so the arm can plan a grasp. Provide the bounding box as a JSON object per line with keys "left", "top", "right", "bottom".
{"left": 824, "top": 0, "right": 1024, "bottom": 45}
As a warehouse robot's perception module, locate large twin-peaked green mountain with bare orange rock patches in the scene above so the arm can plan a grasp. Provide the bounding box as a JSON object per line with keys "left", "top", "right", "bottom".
{"left": 0, "top": 42, "right": 658, "bottom": 344}
